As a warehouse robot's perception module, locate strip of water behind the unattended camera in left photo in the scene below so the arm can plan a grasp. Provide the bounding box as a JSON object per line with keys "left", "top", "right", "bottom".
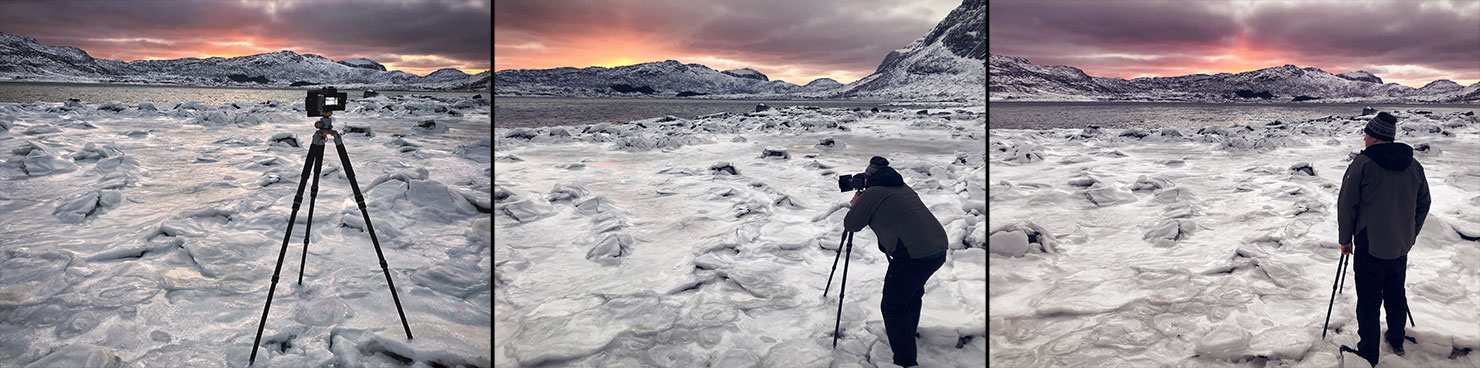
{"left": 0, "top": 81, "right": 491, "bottom": 105}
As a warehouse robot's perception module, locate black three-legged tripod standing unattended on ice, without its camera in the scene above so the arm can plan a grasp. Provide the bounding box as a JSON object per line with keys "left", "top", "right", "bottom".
{"left": 247, "top": 111, "right": 411, "bottom": 365}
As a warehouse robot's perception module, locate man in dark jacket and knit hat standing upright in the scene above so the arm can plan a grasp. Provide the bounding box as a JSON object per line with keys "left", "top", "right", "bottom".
{"left": 1336, "top": 112, "right": 1430, "bottom": 365}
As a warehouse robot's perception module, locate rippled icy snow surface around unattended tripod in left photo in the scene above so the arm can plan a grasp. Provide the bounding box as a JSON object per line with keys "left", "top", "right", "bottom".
{"left": 0, "top": 96, "right": 493, "bottom": 367}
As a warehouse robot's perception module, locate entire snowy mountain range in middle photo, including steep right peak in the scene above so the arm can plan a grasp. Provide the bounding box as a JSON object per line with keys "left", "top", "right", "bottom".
{"left": 493, "top": 0, "right": 987, "bottom": 100}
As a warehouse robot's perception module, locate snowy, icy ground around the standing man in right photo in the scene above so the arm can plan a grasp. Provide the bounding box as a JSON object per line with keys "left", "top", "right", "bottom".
{"left": 987, "top": 107, "right": 1480, "bottom": 367}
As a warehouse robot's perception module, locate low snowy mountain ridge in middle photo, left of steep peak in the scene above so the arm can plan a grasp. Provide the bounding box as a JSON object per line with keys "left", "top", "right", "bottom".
{"left": 493, "top": 61, "right": 802, "bottom": 98}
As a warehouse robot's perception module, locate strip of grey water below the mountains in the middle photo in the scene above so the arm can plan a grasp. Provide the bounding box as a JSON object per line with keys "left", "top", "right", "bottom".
{"left": 493, "top": 98, "right": 898, "bottom": 127}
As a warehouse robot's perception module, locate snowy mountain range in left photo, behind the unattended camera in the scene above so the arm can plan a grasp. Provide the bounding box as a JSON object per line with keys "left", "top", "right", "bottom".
{"left": 0, "top": 33, "right": 488, "bottom": 90}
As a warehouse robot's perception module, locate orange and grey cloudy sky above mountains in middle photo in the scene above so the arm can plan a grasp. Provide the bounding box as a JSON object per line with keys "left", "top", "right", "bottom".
{"left": 493, "top": 0, "right": 961, "bottom": 84}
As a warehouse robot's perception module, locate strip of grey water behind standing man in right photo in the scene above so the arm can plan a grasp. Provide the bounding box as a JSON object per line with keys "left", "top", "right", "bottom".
{"left": 987, "top": 102, "right": 1480, "bottom": 129}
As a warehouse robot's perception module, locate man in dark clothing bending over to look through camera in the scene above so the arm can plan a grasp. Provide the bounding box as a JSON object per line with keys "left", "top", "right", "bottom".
{"left": 844, "top": 157, "right": 947, "bottom": 367}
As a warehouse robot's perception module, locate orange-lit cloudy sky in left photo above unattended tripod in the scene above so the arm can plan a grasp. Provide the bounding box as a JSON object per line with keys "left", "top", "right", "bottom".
{"left": 0, "top": 0, "right": 493, "bottom": 75}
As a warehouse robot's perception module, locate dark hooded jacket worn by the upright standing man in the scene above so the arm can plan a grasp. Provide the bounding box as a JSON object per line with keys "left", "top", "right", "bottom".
{"left": 1336, "top": 143, "right": 1430, "bottom": 260}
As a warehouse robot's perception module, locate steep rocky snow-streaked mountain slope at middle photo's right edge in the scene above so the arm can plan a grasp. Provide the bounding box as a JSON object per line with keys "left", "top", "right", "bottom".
{"left": 839, "top": 0, "right": 987, "bottom": 100}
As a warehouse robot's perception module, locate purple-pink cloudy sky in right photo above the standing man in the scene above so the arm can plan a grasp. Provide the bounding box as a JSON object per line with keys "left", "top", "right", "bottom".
{"left": 987, "top": 0, "right": 1480, "bottom": 87}
